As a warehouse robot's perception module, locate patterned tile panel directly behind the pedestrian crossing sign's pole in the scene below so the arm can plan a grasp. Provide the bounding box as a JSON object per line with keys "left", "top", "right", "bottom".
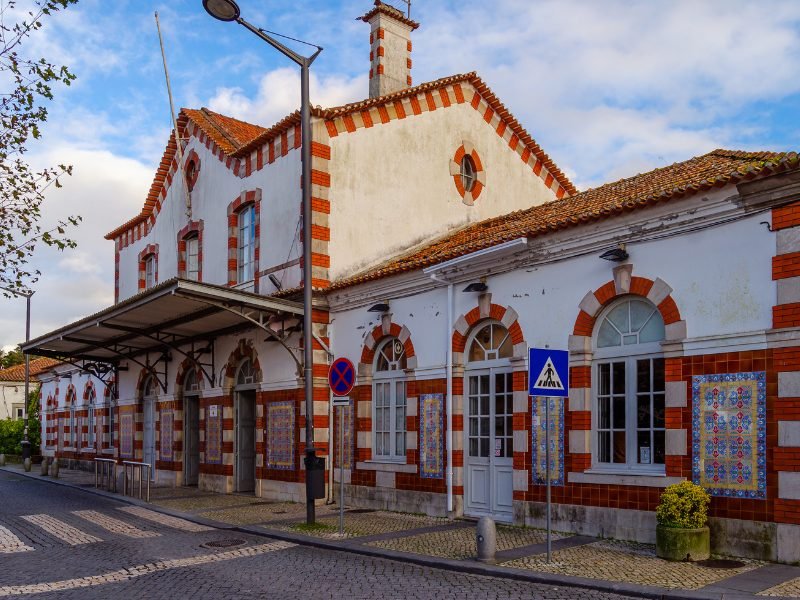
{"left": 531, "top": 396, "right": 564, "bottom": 485}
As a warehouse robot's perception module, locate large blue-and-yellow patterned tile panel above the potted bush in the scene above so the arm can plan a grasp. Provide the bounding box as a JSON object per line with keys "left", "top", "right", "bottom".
{"left": 692, "top": 371, "right": 767, "bottom": 498}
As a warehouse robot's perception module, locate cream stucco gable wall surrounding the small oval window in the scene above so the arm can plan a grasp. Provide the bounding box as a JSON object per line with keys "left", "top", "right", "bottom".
{"left": 330, "top": 94, "right": 555, "bottom": 280}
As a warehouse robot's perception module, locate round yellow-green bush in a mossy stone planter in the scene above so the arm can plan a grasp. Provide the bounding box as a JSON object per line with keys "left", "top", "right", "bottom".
{"left": 656, "top": 481, "right": 711, "bottom": 561}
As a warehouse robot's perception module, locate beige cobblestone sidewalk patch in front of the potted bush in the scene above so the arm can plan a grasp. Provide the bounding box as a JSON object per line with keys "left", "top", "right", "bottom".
{"left": 504, "top": 540, "right": 764, "bottom": 590}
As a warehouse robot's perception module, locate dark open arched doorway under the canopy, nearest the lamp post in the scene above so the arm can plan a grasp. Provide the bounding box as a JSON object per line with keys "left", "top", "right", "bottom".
{"left": 233, "top": 358, "right": 259, "bottom": 492}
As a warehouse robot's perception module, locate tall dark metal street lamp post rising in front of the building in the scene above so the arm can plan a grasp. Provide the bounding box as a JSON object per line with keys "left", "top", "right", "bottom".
{"left": 203, "top": 0, "right": 322, "bottom": 524}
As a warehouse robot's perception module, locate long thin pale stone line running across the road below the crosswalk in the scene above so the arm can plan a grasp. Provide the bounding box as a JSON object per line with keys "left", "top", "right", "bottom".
{"left": 0, "top": 542, "right": 297, "bottom": 597}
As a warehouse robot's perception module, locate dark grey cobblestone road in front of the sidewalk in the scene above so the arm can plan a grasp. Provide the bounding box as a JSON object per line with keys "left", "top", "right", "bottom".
{"left": 0, "top": 471, "right": 644, "bottom": 600}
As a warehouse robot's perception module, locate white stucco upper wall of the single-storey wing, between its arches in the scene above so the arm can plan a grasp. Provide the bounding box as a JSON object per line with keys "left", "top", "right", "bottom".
{"left": 331, "top": 190, "right": 776, "bottom": 370}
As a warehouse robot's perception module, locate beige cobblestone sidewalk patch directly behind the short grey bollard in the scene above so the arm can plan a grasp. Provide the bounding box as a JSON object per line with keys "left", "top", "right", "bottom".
{"left": 369, "top": 525, "right": 564, "bottom": 559}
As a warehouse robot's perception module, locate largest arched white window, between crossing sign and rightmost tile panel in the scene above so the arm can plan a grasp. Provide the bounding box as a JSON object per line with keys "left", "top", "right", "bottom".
{"left": 592, "top": 297, "right": 665, "bottom": 473}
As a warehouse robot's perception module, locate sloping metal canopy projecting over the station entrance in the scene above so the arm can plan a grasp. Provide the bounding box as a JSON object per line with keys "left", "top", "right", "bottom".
{"left": 22, "top": 279, "right": 303, "bottom": 368}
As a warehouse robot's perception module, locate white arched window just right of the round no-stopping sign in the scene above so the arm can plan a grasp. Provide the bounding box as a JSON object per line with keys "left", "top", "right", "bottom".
{"left": 372, "top": 337, "right": 407, "bottom": 461}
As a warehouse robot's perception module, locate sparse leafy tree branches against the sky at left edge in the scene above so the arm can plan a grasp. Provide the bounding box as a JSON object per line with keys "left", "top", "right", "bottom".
{"left": 0, "top": 0, "right": 80, "bottom": 292}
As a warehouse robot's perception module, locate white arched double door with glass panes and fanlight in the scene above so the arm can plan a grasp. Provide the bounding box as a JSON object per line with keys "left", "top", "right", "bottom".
{"left": 464, "top": 320, "right": 514, "bottom": 522}
